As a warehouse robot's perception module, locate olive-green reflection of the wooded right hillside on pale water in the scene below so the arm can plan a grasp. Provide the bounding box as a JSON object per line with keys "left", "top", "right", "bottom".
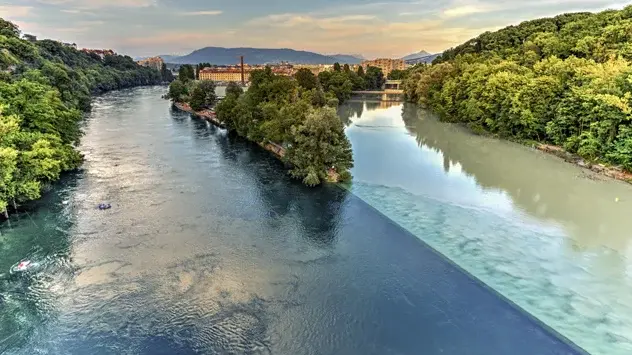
{"left": 402, "top": 104, "right": 632, "bottom": 250}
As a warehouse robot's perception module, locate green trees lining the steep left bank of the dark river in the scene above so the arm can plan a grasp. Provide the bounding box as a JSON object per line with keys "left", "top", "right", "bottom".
{"left": 0, "top": 19, "right": 162, "bottom": 216}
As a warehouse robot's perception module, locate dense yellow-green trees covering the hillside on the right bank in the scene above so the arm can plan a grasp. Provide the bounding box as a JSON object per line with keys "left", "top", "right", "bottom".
{"left": 404, "top": 6, "right": 632, "bottom": 170}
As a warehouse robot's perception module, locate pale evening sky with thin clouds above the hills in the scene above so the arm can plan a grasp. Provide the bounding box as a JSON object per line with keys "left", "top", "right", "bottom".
{"left": 0, "top": 0, "right": 625, "bottom": 58}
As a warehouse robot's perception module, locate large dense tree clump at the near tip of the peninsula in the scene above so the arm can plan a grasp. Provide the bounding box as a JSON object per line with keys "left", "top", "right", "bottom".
{"left": 216, "top": 68, "right": 353, "bottom": 186}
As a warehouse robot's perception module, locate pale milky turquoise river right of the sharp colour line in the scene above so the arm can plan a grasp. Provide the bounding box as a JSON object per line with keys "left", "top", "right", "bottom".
{"left": 341, "top": 102, "right": 632, "bottom": 354}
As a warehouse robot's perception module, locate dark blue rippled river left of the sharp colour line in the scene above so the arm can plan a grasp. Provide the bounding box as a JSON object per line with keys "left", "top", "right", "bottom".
{"left": 0, "top": 88, "right": 581, "bottom": 355}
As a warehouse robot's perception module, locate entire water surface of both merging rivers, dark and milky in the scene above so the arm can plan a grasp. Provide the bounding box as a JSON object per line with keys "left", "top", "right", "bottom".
{"left": 0, "top": 87, "right": 632, "bottom": 355}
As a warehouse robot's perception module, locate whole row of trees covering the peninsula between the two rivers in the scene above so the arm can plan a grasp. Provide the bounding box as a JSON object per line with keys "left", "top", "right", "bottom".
{"left": 168, "top": 63, "right": 385, "bottom": 186}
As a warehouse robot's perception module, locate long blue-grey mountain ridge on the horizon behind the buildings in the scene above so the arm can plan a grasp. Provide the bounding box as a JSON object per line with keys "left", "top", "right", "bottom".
{"left": 161, "top": 47, "right": 363, "bottom": 65}
